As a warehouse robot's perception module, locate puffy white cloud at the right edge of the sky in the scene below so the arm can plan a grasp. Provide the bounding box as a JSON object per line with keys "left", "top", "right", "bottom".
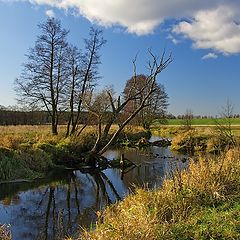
{"left": 173, "top": 6, "right": 240, "bottom": 54}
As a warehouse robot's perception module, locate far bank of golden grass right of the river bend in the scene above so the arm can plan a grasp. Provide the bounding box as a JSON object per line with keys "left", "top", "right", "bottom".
{"left": 151, "top": 125, "right": 240, "bottom": 155}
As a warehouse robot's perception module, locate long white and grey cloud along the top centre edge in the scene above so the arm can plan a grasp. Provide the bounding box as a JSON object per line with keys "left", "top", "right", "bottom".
{"left": 9, "top": 0, "right": 225, "bottom": 35}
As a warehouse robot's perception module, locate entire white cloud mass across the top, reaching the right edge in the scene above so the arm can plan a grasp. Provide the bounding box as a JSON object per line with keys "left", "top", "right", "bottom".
{"left": 3, "top": 0, "right": 240, "bottom": 54}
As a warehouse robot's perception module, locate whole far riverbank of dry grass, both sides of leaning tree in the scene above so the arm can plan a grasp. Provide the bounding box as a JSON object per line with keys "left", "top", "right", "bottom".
{"left": 0, "top": 125, "right": 239, "bottom": 182}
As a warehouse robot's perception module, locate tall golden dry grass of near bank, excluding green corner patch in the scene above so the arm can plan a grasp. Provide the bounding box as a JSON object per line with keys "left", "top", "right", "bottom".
{"left": 80, "top": 149, "right": 240, "bottom": 240}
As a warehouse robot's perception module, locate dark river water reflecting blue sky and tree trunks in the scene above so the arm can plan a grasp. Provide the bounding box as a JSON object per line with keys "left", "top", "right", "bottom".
{"left": 0, "top": 142, "right": 187, "bottom": 240}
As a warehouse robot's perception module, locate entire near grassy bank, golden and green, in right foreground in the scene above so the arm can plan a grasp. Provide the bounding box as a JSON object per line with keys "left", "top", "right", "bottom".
{"left": 79, "top": 149, "right": 240, "bottom": 240}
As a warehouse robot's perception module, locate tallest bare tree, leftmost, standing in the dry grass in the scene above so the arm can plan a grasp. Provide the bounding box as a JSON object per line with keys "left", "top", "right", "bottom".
{"left": 15, "top": 18, "right": 68, "bottom": 135}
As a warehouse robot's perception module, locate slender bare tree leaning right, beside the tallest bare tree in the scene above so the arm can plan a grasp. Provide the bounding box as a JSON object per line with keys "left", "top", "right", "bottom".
{"left": 67, "top": 28, "right": 106, "bottom": 135}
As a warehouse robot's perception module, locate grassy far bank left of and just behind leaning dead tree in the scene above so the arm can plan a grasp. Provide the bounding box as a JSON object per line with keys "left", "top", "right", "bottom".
{"left": 0, "top": 126, "right": 147, "bottom": 181}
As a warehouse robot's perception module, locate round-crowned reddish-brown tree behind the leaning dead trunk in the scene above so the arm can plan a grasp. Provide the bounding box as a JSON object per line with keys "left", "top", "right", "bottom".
{"left": 123, "top": 74, "right": 168, "bottom": 130}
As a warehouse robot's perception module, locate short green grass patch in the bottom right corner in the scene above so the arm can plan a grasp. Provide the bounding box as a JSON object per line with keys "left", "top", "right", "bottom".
{"left": 167, "top": 199, "right": 240, "bottom": 240}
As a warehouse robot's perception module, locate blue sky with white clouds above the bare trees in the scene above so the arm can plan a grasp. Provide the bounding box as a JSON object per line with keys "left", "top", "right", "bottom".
{"left": 0, "top": 0, "right": 240, "bottom": 115}
